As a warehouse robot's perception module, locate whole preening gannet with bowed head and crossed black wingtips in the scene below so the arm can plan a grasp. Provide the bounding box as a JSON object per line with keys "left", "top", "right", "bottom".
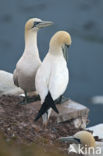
{"left": 35, "top": 31, "right": 71, "bottom": 125}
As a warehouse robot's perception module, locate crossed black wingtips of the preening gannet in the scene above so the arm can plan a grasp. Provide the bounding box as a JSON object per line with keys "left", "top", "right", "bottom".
{"left": 34, "top": 93, "right": 59, "bottom": 121}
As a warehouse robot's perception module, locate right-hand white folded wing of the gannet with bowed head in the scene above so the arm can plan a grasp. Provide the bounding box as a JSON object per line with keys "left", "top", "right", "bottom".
{"left": 49, "top": 61, "right": 69, "bottom": 100}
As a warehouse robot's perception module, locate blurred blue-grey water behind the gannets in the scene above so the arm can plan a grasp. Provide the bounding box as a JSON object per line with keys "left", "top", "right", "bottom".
{"left": 0, "top": 0, "right": 103, "bottom": 125}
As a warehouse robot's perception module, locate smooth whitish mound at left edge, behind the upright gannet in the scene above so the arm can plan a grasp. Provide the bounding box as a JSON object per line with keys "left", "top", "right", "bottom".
{"left": 0, "top": 70, "right": 23, "bottom": 96}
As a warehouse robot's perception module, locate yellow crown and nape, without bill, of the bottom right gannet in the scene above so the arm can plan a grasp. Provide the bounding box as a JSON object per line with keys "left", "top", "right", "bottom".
{"left": 74, "top": 131, "right": 96, "bottom": 147}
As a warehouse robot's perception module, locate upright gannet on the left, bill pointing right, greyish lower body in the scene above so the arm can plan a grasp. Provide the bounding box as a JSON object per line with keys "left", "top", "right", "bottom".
{"left": 13, "top": 18, "right": 53, "bottom": 103}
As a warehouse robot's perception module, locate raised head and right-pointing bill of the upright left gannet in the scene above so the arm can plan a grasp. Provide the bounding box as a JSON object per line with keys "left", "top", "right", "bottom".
{"left": 25, "top": 18, "right": 53, "bottom": 31}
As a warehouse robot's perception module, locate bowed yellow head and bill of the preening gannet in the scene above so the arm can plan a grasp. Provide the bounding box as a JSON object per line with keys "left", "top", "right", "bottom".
{"left": 49, "top": 31, "right": 72, "bottom": 61}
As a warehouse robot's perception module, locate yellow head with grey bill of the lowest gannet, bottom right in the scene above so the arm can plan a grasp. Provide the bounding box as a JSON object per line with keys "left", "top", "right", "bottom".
{"left": 59, "top": 131, "right": 96, "bottom": 147}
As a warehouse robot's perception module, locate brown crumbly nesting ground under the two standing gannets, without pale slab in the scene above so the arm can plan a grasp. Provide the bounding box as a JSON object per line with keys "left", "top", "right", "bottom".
{"left": 0, "top": 95, "right": 85, "bottom": 144}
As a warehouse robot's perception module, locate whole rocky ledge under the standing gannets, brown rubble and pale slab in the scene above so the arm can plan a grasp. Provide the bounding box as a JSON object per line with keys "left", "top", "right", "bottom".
{"left": 0, "top": 95, "right": 89, "bottom": 147}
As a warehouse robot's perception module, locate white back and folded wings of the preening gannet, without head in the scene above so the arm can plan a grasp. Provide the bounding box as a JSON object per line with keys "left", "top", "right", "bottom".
{"left": 35, "top": 52, "right": 69, "bottom": 103}
